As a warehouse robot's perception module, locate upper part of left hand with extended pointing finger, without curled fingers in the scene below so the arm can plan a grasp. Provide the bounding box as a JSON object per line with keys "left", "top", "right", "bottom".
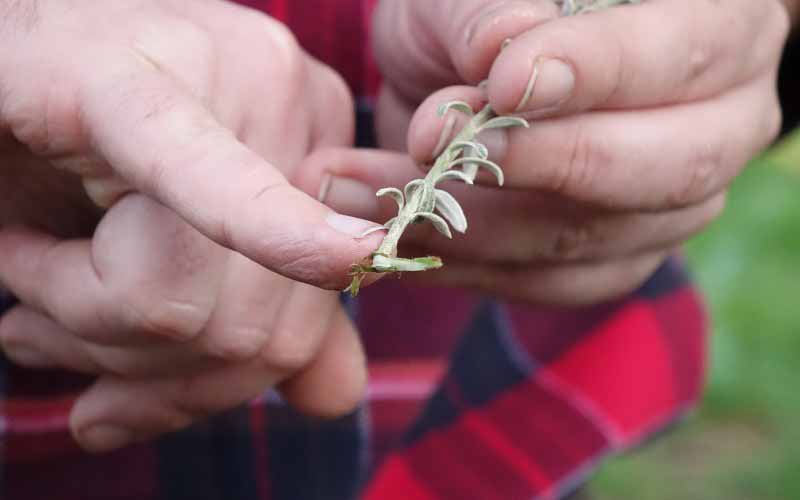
{"left": 0, "top": 0, "right": 379, "bottom": 289}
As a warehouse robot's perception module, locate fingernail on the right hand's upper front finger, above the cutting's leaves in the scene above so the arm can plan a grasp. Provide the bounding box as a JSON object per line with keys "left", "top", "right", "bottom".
{"left": 515, "top": 57, "right": 575, "bottom": 118}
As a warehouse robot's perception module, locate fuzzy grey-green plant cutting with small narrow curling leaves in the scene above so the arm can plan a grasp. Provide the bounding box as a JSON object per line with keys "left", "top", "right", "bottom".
{"left": 345, "top": 0, "right": 643, "bottom": 296}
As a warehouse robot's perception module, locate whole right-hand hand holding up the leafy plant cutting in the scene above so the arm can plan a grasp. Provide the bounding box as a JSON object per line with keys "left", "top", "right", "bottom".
{"left": 298, "top": 0, "right": 789, "bottom": 304}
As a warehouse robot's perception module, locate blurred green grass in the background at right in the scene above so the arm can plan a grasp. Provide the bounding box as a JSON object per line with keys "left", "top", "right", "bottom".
{"left": 593, "top": 143, "right": 800, "bottom": 500}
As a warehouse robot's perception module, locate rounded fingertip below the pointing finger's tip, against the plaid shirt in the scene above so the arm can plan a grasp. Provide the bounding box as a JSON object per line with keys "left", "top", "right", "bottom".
{"left": 280, "top": 308, "right": 367, "bottom": 417}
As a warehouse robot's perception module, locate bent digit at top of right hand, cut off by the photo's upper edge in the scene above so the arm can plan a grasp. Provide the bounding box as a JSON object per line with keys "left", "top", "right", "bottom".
{"left": 374, "top": 0, "right": 558, "bottom": 102}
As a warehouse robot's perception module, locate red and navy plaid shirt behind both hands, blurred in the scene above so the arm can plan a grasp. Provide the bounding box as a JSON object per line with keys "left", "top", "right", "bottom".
{"left": 0, "top": 0, "right": 705, "bottom": 500}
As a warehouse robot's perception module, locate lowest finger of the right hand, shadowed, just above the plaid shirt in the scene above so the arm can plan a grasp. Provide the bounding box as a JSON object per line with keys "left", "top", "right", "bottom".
{"left": 404, "top": 251, "right": 669, "bottom": 307}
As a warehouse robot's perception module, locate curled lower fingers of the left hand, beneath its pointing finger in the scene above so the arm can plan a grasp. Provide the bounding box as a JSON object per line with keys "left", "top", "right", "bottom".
{"left": 0, "top": 201, "right": 366, "bottom": 451}
